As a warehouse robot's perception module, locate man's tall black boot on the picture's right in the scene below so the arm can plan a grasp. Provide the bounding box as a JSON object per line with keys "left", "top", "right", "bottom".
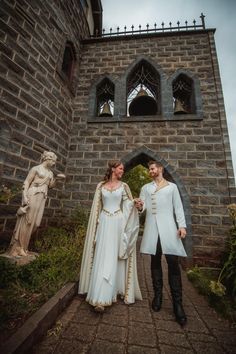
{"left": 169, "top": 274, "right": 187, "bottom": 326}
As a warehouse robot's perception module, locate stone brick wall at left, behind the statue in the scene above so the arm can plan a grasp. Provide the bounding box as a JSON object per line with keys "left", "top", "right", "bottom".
{"left": 0, "top": 0, "right": 89, "bottom": 238}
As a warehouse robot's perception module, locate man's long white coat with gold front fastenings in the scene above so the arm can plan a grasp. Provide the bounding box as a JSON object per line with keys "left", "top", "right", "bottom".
{"left": 140, "top": 180, "right": 187, "bottom": 257}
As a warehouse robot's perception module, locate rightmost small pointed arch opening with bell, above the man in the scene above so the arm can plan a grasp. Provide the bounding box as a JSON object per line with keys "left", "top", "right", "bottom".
{"left": 172, "top": 74, "right": 196, "bottom": 114}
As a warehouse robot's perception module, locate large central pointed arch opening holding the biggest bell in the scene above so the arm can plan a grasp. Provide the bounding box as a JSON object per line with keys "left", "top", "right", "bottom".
{"left": 127, "top": 60, "right": 161, "bottom": 116}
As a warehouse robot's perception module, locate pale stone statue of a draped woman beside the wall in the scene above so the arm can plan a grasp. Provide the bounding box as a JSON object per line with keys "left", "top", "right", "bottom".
{"left": 7, "top": 151, "right": 65, "bottom": 257}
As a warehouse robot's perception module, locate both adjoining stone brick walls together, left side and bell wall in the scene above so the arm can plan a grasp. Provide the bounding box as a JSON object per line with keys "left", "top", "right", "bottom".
{"left": 0, "top": 0, "right": 236, "bottom": 265}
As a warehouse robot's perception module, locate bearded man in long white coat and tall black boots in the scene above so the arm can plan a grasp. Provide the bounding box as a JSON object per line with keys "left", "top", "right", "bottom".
{"left": 136, "top": 161, "right": 187, "bottom": 326}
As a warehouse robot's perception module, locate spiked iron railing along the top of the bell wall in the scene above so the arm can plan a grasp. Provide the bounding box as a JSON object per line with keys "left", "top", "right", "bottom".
{"left": 92, "top": 13, "right": 205, "bottom": 38}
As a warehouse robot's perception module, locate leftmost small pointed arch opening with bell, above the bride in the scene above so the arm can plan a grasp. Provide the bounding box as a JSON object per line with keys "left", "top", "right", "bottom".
{"left": 96, "top": 78, "right": 115, "bottom": 117}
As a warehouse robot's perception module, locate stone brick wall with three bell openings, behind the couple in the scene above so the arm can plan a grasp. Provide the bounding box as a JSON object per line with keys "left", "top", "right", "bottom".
{"left": 67, "top": 30, "right": 235, "bottom": 264}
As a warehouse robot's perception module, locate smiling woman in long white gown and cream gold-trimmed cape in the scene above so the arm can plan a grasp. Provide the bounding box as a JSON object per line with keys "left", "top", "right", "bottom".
{"left": 79, "top": 160, "right": 142, "bottom": 312}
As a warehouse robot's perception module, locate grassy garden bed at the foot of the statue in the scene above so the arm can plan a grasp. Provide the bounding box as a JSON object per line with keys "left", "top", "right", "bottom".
{"left": 0, "top": 206, "right": 88, "bottom": 340}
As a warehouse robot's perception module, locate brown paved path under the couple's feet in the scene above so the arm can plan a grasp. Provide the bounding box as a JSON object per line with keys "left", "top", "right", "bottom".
{"left": 30, "top": 246, "right": 236, "bottom": 354}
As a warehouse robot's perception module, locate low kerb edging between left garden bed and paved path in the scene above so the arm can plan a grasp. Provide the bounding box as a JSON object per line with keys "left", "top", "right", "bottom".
{"left": 0, "top": 282, "right": 78, "bottom": 354}
